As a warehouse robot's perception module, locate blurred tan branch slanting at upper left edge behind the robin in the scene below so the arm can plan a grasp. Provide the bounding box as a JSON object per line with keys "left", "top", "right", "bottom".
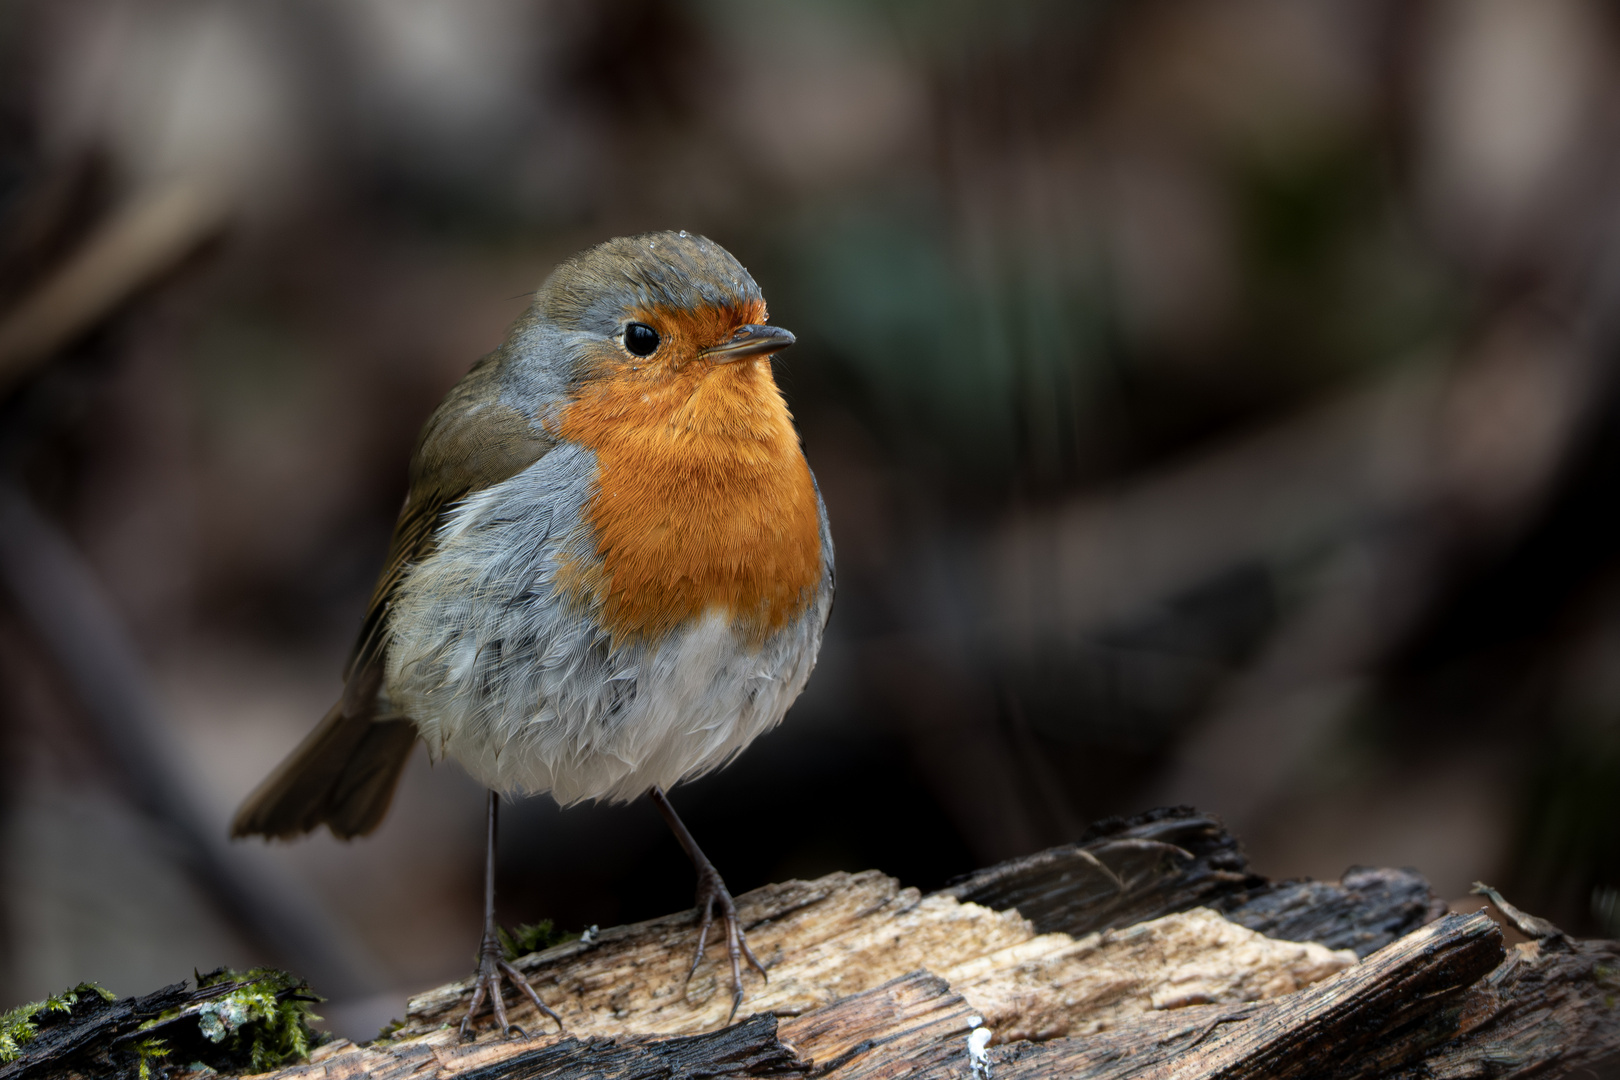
{"left": 0, "top": 180, "right": 228, "bottom": 395}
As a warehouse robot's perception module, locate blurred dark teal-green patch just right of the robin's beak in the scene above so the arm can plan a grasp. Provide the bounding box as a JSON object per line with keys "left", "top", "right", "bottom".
{"left": 794, "top": 202, "right": 1103, "bottom": 481}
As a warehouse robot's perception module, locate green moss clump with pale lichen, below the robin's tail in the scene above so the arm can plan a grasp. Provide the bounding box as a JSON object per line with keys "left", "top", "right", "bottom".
{"left": 196, "top": 968, "right": 322, "bottom": 1072}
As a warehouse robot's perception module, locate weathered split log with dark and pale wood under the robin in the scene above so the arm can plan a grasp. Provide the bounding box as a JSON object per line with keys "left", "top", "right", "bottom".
{"left": 6, "top": 808, "right": 1620, "bottom": 1080}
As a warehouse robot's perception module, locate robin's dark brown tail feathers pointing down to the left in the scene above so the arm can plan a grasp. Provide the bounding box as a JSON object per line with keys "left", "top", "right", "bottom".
{"left": 230, "top": 680, "right": 416, "bottom": 840}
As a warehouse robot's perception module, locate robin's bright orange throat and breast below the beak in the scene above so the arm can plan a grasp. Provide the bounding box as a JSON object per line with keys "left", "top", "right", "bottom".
{"left": 557, "top": 333, "right": 821, "bottom": 644}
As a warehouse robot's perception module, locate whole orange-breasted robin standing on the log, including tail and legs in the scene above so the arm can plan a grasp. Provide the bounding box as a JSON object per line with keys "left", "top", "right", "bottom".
{"left": 232, "top": 232, "right": 833, "bottom": 1038}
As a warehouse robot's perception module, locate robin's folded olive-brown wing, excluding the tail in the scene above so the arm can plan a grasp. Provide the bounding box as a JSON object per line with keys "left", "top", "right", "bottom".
{"left": 343, "top": 353, "right": 556, "bottom": 683}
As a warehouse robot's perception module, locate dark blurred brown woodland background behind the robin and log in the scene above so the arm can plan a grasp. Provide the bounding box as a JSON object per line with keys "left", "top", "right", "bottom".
{"left": 0, "top": 0, "right": 1620, "bottom": 1036}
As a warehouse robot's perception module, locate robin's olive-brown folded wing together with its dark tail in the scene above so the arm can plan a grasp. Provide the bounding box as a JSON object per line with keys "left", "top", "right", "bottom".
{"left": 232, "top": 353, "right": 554, "bottom": 839}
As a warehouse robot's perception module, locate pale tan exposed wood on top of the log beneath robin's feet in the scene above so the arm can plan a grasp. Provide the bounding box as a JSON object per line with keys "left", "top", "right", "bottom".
{"left": 397, "top": 873, "right": 1356, "bottom": 1040}
